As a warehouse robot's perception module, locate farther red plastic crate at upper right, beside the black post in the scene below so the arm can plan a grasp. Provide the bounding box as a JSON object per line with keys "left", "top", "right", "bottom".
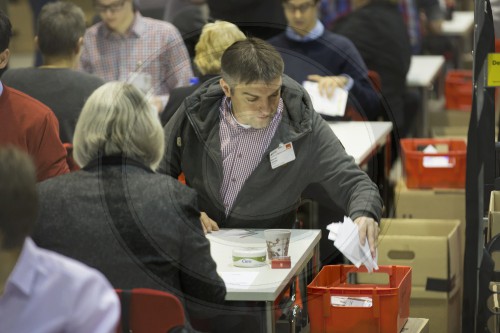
{"left": 444, "top": 69, "right": 472, "bottom": 111}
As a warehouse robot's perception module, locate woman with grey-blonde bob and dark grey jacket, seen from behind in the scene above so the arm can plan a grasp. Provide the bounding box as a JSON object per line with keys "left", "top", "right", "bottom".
{"left": 33, "top": 82, "right": 226, "bottom": 326}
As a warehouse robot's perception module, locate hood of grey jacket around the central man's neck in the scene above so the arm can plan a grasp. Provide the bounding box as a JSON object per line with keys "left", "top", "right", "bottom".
{"left": 183, "top": 75, "right": 315, "bottom": 140}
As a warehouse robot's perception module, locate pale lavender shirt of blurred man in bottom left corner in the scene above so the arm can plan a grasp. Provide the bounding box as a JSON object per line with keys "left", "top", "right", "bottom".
{"left": 0, "top": 238, "right": 120, "bottom": 333}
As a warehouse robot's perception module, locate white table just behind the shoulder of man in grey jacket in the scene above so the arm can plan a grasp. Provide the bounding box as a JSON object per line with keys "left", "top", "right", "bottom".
{"left": 328, "top": 121, "right": 392, "bottom": 165}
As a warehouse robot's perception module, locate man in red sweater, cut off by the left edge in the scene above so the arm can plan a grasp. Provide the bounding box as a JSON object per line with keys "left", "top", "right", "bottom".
{"left": 0, "top": 11, "right": 69, "bottom": 181}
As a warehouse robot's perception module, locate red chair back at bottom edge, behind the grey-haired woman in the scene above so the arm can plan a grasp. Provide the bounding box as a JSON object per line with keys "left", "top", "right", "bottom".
{"left": 116, "top": 288, "right": 186, "bottom": 333}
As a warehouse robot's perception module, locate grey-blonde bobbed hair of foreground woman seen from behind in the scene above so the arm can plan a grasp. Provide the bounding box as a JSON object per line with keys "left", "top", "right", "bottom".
{"left": 73, "top": 82, "right": 164, "bottom": 170}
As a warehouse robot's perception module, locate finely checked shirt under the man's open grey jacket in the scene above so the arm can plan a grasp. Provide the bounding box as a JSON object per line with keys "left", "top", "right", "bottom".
{"left": 219, "top": 97, "right": 283, "bottom": 216}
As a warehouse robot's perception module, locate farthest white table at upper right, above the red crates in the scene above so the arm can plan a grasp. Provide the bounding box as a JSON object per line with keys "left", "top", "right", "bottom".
{"left": 441, "top": 11, "right": 474, "bottom": 68}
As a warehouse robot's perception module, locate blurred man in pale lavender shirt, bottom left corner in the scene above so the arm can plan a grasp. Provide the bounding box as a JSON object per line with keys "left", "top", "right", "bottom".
{"left": 0, "top": 147, "right": 120, "bottom": 333}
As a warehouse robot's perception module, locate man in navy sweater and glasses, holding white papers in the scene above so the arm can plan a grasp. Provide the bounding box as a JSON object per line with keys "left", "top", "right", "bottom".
{"left": 269, "top": 0, "right": 381, "bottom": 120}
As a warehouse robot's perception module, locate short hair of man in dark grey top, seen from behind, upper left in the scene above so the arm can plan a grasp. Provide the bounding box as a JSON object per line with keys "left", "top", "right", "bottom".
{"left": 37, "top": 1, "right": 86, "bottom": 56}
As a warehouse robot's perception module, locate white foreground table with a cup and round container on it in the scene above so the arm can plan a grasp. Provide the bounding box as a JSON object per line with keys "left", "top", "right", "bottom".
{"left": 207, "top": 229, "right": 321, "bottom": 332}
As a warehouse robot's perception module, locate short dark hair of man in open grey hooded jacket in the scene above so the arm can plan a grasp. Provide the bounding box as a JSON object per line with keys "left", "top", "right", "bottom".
{"left": 221, "top": 38, "right": 285, "bottom": 88}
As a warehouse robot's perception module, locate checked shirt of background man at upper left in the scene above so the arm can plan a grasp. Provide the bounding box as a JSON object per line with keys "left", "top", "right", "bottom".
{"left": 80, "top": 13, "right": 193, "bottom": 95}
